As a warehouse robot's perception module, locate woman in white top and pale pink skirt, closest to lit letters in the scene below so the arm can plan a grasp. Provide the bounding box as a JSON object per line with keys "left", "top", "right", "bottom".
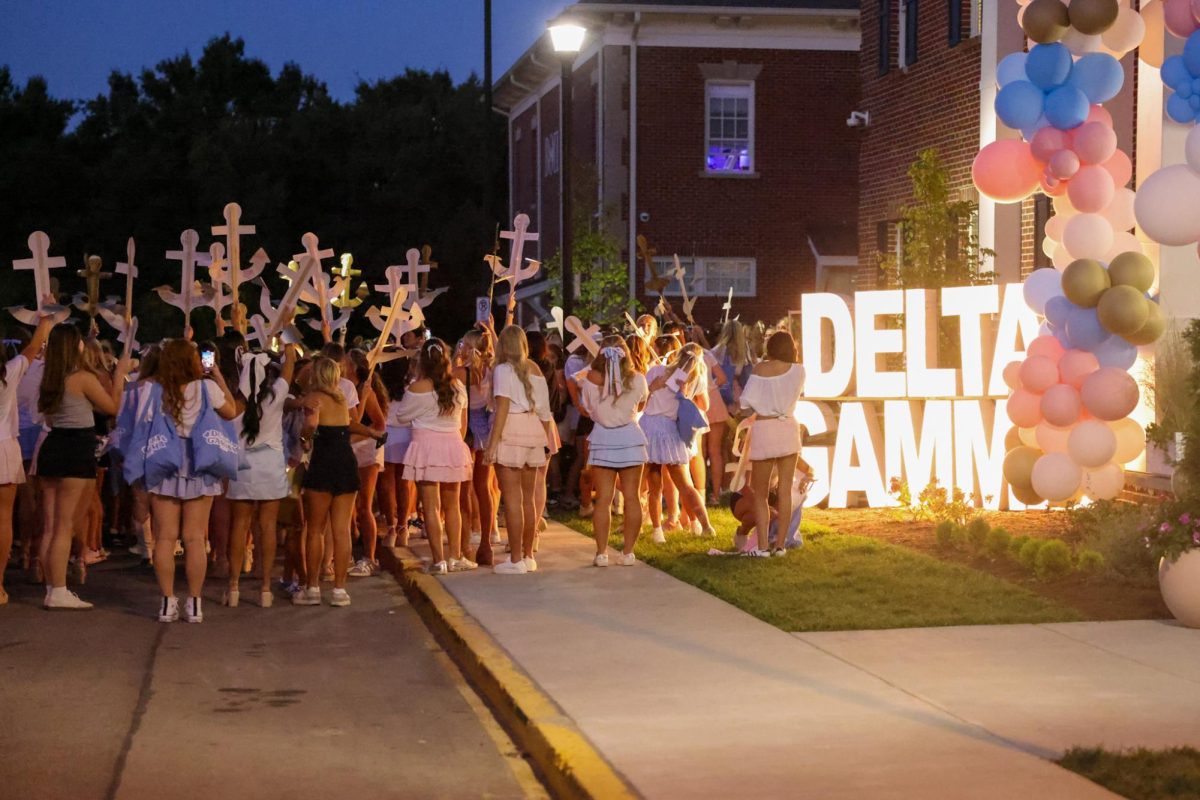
{"left": 742, "top": 331, "right": 804, "bottom": 558}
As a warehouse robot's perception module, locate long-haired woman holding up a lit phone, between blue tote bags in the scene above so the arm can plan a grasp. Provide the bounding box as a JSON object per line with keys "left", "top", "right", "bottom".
{"left": 138, "top": 339, "right": 238, "bottom": 622}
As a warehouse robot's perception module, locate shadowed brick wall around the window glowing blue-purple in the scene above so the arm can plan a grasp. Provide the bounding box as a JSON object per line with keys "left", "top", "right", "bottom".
{"left": 635, "top": 47, "right": 859, "bottom": 325}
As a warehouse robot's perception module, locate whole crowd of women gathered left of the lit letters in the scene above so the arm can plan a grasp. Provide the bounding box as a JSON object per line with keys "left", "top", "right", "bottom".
{"left": 0, "top": 303, "right": 804, "bottom": 622}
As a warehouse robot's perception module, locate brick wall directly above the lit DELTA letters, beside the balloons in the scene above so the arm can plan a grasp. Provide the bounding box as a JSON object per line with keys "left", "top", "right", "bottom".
{"left": 864, "top": 0, "right": 980, "bottom": 289}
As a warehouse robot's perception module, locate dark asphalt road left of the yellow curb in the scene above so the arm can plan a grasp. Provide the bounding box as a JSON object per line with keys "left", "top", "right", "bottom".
{"left": 0, "top": 560, "right": 545, "bottom": 800}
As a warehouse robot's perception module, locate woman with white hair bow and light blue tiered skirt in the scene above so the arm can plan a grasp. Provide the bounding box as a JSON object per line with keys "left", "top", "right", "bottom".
{"left": 580, "top": 336, "right": 649, "bottom": 566}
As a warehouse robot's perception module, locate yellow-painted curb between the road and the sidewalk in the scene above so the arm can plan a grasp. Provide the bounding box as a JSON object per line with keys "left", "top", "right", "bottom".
{"left": 379, "top": 547, "right": 640, "bottom": 800}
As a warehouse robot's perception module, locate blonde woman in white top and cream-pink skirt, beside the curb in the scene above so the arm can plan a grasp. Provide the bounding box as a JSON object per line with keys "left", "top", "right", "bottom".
{"left": 486, "top": 325, "right": 553, "bottom": 575}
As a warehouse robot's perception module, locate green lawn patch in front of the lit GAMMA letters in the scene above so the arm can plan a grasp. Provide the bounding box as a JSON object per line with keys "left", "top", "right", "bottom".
{"left": 556, "top": 509, "right": 1080, "bottom": 631}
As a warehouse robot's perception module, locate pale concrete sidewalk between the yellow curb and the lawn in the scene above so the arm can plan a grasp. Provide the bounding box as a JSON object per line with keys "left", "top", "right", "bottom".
{"left": 415, "top": 523, "right": 1200, "bottom": 798}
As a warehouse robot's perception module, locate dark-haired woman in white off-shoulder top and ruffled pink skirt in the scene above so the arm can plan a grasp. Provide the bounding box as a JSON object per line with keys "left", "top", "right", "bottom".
{"left": 394, "top": 338, "right": 468, "bottom": 575}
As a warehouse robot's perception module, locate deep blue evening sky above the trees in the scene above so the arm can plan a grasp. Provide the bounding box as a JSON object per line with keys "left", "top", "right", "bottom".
{"left": 0, "top": 0, "right": 569, "bottom": 100}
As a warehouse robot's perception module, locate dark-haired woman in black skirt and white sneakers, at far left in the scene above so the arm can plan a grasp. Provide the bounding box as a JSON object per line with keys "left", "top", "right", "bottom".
{"left": 35, "top": 323, "right": 130, "bottom": 610}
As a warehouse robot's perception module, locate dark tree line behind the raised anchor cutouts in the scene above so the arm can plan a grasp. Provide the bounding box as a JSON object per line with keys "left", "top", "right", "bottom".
{"left": 0, "top": 35, "right": 505, "bottom": 341}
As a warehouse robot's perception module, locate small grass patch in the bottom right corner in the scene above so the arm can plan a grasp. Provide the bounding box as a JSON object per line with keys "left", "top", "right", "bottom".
{"left": 1058, "top": 747, "right": 1200, "bottom": 800}
